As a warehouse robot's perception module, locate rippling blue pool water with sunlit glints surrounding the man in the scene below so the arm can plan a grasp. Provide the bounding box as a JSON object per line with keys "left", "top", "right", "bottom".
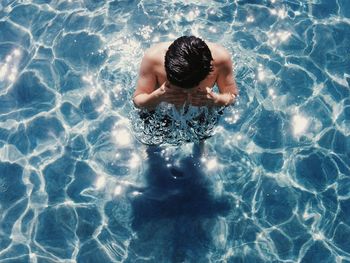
{"left": 0, "top": 0, "right": 350, "bottom": 263}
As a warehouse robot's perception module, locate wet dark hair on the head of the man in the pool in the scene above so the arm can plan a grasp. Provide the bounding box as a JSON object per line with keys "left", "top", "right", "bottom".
{"left": 165, "top": 36, "right": 213, "bottom": 89}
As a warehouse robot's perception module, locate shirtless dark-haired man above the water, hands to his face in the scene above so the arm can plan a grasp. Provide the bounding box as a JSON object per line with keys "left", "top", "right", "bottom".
{"left": 133, "top": 36, "right": 238, "bottom": 110}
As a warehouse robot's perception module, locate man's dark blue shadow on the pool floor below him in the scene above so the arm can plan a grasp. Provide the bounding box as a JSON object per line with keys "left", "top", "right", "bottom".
{"left": 130, "top": 146, "right": 231, "bottom": 262}
